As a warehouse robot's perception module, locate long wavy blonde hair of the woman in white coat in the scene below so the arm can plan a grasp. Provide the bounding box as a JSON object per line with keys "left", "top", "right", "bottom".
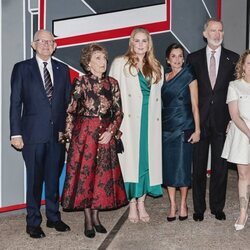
{"left": 124, "top": 28, "right": 162, "bottom": 84}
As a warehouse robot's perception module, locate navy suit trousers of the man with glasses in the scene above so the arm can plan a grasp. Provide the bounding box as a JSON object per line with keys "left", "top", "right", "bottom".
{"left": 23, "top": 133, "right": 65, "bottom": 227}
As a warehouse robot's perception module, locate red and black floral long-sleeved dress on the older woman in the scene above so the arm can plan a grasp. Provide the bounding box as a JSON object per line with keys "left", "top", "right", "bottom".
{"left": 62, "top": 74, "right": 127, "bottom": 211}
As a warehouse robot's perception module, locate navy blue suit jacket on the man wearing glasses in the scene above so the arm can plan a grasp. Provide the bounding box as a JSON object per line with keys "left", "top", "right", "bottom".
{"left": 10, "top": 57, "right": 71, "bottom": 143}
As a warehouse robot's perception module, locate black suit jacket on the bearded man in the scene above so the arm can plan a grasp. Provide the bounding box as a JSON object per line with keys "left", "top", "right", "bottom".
{"left": 187, "top": 47, "right": 239, "bottom": 132}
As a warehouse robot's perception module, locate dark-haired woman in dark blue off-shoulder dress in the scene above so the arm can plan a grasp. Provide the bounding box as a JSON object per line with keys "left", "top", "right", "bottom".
{"left": 162, "top": 44, "right": 200, "bottom": 221}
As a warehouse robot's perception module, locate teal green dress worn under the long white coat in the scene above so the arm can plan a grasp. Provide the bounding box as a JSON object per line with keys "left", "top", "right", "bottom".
{"left": 125, "top": 72, "right": 162, "bottom": 200}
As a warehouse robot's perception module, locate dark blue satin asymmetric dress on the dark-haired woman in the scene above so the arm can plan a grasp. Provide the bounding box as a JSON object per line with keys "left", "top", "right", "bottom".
{"left": 162, "top": 65, "right": 195, "bottom": 187}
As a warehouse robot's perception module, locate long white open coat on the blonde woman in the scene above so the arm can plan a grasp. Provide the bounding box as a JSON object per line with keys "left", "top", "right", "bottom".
{"left": 110, "top": 57, "right": 164, "bottom": 186}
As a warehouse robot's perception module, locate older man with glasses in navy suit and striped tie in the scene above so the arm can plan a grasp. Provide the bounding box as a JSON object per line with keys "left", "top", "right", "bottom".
{"left": 10, "top": 30, "right": 71, "bottom": 238}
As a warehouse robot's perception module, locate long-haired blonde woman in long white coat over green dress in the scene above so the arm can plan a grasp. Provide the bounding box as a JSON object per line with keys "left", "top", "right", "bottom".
{"left": 110, "top": 28, "right": 163, "bottom": 223}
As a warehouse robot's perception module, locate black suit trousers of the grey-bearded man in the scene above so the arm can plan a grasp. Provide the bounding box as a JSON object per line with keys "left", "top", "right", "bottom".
{"left": 193, "top": 120, "right": 228, "bottom": 214}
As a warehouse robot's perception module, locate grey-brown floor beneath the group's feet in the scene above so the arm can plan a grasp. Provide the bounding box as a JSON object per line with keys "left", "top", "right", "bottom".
{"left": 0, "top": 170, "right": 250, "bottom": 250}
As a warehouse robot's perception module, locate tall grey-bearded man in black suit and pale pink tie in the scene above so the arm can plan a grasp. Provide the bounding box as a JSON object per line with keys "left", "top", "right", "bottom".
{"left": 187, "top": 19, "right": 239, "bottom": 221}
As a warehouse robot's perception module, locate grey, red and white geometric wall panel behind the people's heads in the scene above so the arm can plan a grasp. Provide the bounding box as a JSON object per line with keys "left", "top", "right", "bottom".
{"left": 39, "top": 0, "right": 221, "bottom": 76}
